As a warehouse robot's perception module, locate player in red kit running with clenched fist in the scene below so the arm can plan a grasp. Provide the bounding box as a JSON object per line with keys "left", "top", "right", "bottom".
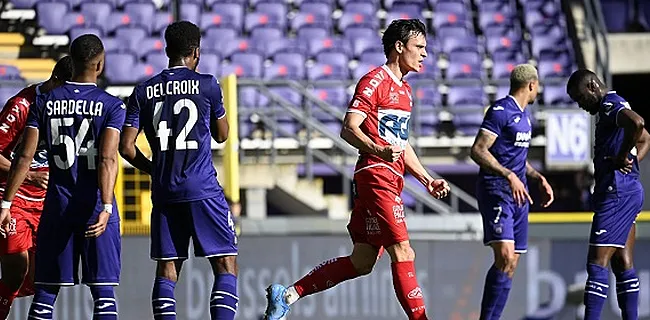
{"left": 265, "top": 19, "right": 449, "bottom": 320}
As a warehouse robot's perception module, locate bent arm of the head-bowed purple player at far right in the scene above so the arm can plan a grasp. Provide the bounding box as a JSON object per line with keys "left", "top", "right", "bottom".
{"left": 614, "top": 108, "right": 645, "bottom": 172}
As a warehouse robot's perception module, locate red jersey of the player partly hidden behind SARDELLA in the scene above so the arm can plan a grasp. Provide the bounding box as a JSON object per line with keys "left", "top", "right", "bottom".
{"left": 0, "top": 85, "right": 48, "bottom": 202}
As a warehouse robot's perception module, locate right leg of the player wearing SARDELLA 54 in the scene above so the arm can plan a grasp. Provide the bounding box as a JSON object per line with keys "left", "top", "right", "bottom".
{"left": 81, "top": 220, "right": 122, "bottom": 320}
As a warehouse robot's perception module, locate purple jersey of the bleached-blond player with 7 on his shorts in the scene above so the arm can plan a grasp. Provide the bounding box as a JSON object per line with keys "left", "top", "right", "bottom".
{"left": 479, "top": 96, "right": 532, "bottom": 191}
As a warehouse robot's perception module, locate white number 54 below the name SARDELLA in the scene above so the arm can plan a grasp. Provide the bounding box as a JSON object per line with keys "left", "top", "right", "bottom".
{"left": 50, "top": 118, "right": 97, "bottom": 170}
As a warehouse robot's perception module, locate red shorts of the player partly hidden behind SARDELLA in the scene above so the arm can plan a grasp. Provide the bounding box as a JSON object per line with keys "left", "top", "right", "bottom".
{"left": 0, "top": 197, "right": 43, "bottom": 255}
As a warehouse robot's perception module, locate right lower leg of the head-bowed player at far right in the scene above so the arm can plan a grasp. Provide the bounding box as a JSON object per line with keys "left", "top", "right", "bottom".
{"left": 611, "top": 224, "right": 639, "bottom": 320}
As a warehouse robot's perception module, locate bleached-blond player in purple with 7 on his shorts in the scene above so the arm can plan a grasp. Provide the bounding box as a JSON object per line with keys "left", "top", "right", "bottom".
{"left": 471, "top": 64, "right": 553, "bottom": 320}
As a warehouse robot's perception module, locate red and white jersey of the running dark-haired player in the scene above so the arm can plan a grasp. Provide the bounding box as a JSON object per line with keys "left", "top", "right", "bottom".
{"left": 348, "top": 65, "right": 413, "bottom": 189}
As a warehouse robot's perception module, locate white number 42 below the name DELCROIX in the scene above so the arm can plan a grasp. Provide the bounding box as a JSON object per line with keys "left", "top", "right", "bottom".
{"left": 153, "top": 99, "right": 199, "bottom": 151}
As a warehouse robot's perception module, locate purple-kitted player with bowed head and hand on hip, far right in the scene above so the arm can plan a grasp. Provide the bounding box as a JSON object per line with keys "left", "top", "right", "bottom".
{"left": 567, "top": 69, "right": 650, "bottom": 320}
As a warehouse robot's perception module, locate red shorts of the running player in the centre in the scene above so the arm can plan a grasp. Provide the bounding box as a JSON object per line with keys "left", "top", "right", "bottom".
{"left": 348, "top": 169, "right": 409, "bottom": 248}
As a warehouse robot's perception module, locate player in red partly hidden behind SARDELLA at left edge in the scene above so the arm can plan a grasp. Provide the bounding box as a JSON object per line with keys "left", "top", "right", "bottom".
{"left": 0, "top": 56, "right": 73, "bottom": 319}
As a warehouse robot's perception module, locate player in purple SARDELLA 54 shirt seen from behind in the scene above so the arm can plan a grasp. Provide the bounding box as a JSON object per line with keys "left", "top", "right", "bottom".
{"left": 0, "top": 34, "right": 126, "bottom": 320}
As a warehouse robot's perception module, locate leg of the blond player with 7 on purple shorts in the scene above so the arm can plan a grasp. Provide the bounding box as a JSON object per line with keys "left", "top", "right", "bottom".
{"left": 478, "top": 196, "right": 526, "bottom": 320}
